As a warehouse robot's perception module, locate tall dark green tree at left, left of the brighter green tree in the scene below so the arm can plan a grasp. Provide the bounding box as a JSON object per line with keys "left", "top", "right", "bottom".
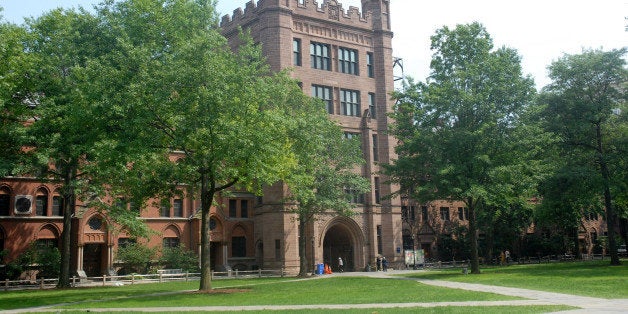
{"left": 15, "top": 2, "right": 159, "bottom": 287}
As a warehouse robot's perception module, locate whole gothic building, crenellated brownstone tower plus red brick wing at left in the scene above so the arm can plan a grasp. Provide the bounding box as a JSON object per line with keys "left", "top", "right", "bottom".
{"left": 0, "top": 0, "right": 403, "bottom": 276}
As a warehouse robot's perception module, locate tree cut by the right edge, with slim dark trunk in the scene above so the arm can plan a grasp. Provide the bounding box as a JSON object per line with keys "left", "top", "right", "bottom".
{"left": 542, "top": 48, "right": 628, "bottom": 265}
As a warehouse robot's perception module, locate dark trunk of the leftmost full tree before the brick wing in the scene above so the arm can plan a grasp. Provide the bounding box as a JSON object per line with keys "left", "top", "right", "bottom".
{"left": 57, "top": 169, "right": 76, "bottom": 288}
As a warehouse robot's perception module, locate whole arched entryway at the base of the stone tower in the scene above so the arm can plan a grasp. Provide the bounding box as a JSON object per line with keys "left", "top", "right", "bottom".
{"left": 323, "top": 219, "right": 363, "bottom": 271}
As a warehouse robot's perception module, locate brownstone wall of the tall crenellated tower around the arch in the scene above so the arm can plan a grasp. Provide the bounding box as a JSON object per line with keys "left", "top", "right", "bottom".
{"left": 221, "top": 0, "right": 402, "bottom": 272}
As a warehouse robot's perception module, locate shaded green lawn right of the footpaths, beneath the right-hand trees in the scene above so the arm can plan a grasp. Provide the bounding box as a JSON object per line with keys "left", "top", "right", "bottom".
{"left": 412, "top": 260, "right": 628, "bottom": 299}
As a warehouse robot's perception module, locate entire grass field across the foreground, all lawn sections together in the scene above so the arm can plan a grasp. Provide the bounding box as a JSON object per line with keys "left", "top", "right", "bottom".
{"left": 0, "top": 262, "right": 628, "bottom": 313}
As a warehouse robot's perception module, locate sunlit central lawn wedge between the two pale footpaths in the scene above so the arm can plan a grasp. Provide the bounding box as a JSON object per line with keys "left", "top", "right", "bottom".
{"left": 55, "top": 277, "right": 517, "bottom": 308}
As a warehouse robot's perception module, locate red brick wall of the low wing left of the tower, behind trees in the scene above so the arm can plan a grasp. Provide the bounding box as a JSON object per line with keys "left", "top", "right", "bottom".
{"left": 0, "top": 177, "right": 258, "bottom": 276}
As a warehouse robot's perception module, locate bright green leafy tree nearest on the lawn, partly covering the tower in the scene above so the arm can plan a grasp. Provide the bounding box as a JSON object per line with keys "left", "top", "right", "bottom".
{"left": 101, "top": 0, "right": 306, "bottom": 291}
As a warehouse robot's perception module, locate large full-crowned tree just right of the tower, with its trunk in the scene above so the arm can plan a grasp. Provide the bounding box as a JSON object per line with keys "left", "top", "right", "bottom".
{"left": 387, "top": 22, "right": 534, "bottom": 274}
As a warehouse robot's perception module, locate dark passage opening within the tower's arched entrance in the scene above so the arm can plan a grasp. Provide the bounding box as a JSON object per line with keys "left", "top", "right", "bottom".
{"left": 323, "top": 225, "right": 355, "bottom": 271}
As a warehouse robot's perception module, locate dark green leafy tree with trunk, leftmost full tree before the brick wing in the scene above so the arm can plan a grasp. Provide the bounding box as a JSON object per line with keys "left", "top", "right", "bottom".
{"left": 19, "top": 9, "right": 136, "bottom": 287}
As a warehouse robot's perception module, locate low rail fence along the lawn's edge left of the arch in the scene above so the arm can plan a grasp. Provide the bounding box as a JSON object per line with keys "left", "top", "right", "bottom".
{"left": 2, "top": 269, "right": 286, "bottom": 291}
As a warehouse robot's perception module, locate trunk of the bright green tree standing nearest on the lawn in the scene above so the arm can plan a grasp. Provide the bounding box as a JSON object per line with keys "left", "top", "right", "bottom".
{"left": 198, "top": 172, "right": 215, "bottom": 291}
